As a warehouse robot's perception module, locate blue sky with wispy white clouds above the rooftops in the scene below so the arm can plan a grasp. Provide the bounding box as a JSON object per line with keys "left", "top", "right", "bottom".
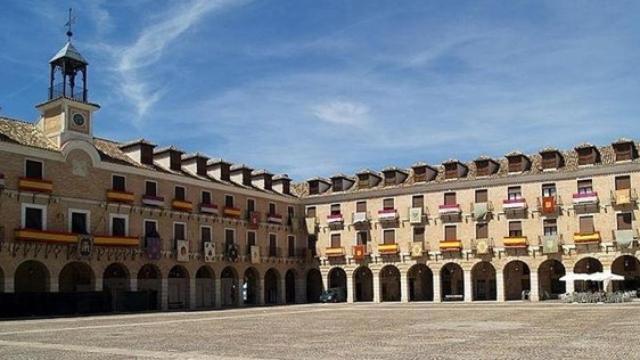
{"left": 0, "top": 0, "right": 640, "bottom": 180}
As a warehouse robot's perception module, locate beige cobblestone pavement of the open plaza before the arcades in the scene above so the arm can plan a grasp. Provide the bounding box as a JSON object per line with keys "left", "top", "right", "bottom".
{"left": 0, "top": 303, "right": 640, "bottom": 359}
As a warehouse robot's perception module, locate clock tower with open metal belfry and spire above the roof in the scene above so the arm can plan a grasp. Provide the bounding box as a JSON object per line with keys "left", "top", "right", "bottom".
{"left": 36, "top": 9, "right": 100, "bottom": 147}
